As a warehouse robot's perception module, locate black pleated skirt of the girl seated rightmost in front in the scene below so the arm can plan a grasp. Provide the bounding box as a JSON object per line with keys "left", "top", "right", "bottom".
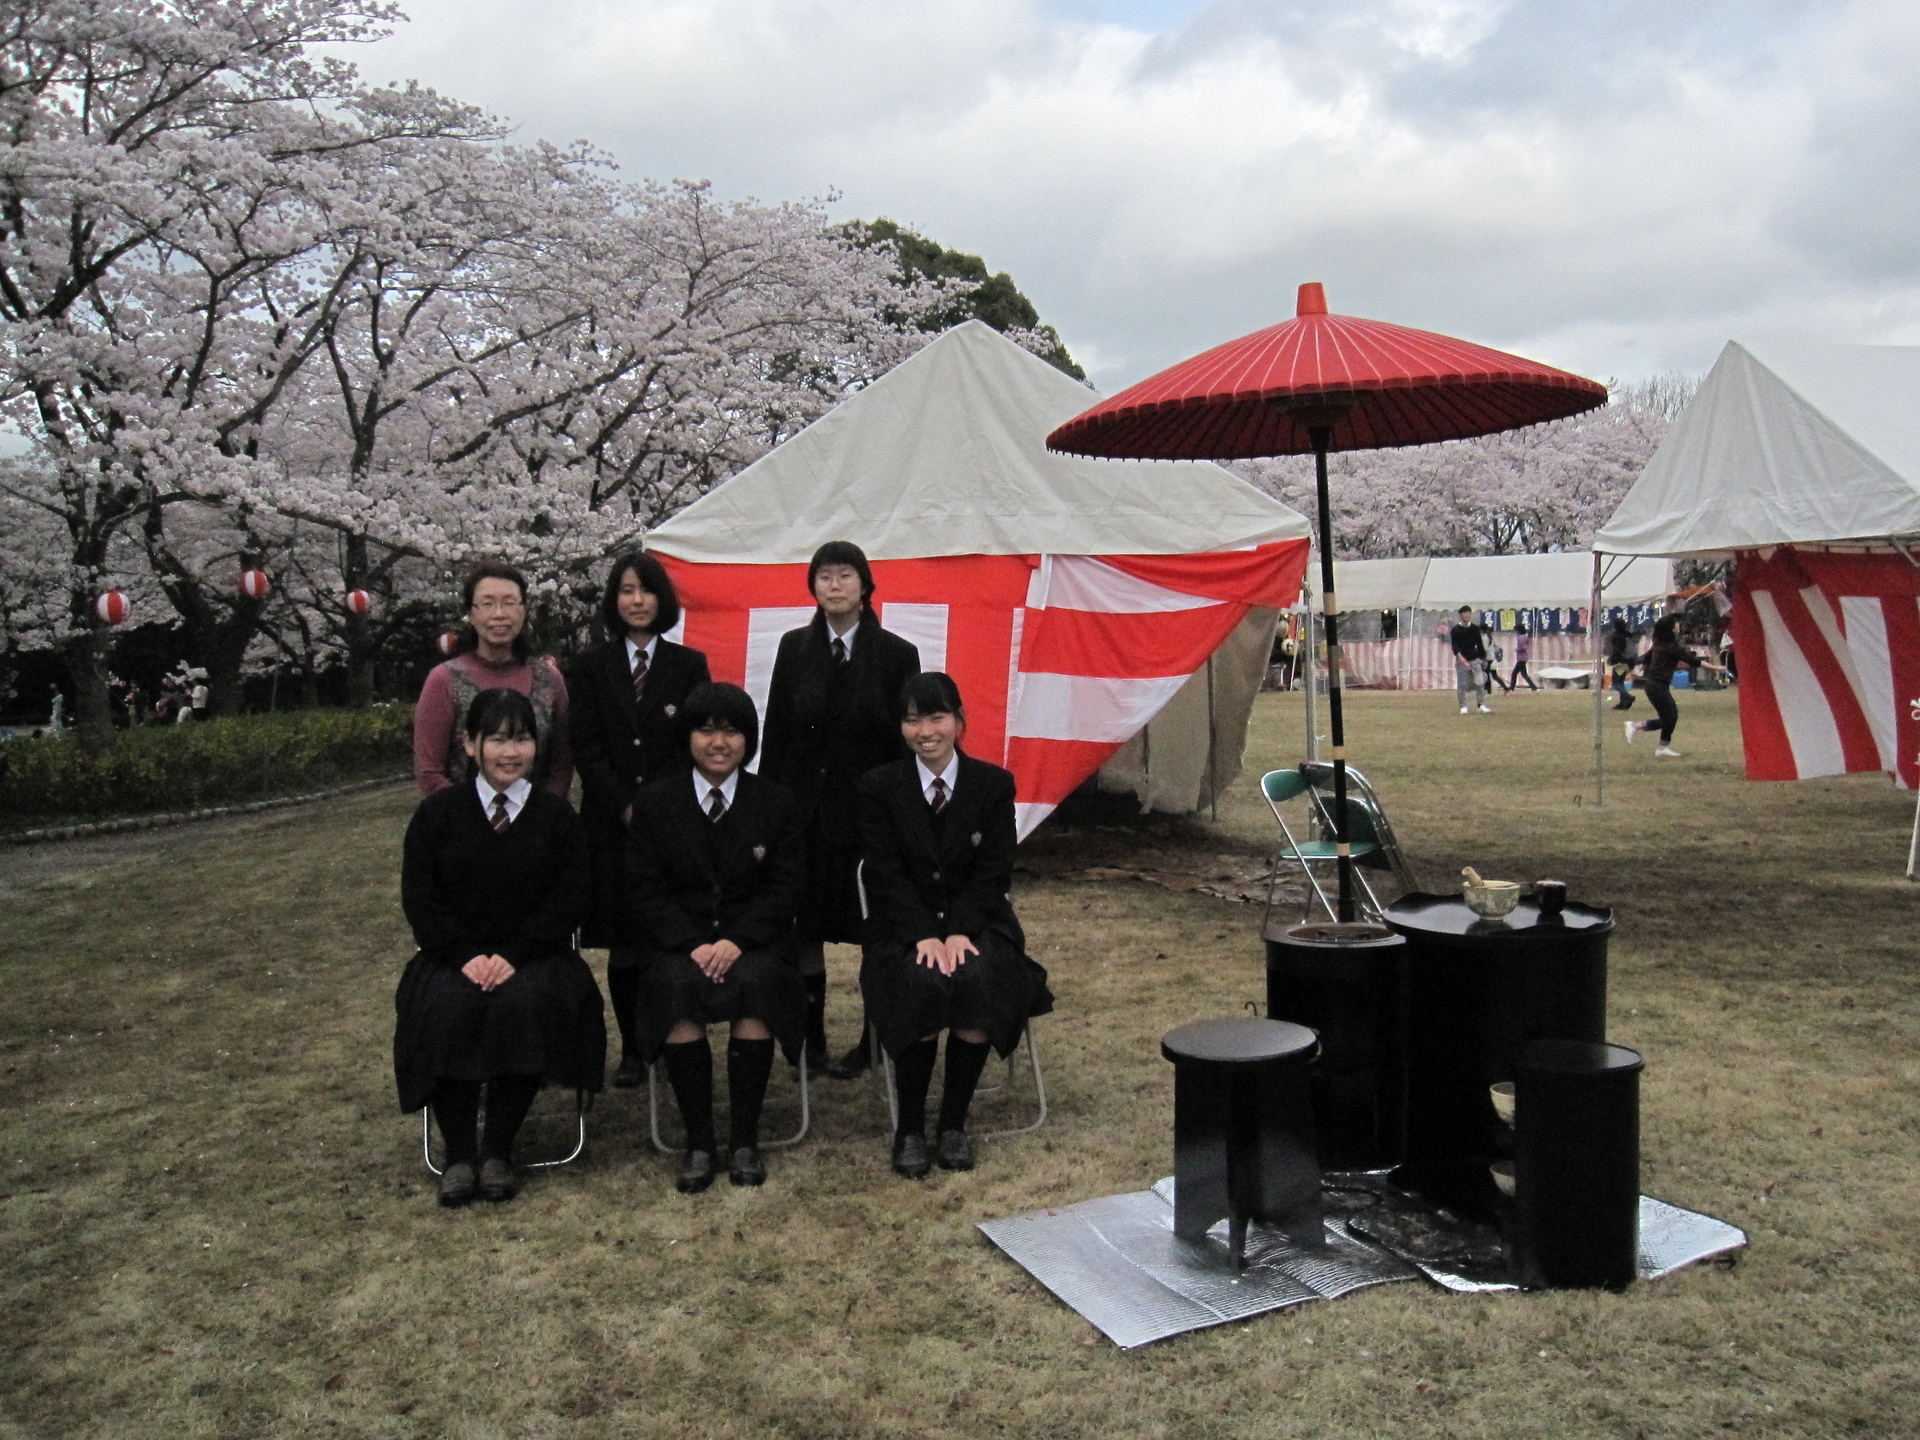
{"left": 860, "top": 931, "right": 1054, "bottom": 1058}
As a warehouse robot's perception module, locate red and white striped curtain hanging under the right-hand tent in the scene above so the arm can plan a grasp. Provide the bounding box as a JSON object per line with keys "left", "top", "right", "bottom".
{"left": 1734, "top": 545, "right": 1920, "bottom": 789}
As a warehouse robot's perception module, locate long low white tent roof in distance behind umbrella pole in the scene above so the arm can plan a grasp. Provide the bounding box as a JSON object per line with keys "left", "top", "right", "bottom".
{"left": 1308, "top": 549, "right": 1672, "bottom": 611}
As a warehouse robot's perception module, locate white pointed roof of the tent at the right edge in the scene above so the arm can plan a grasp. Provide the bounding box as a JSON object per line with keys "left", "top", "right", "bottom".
{"left": 1594, "top": 342, "right": 1920, "bottom": 555}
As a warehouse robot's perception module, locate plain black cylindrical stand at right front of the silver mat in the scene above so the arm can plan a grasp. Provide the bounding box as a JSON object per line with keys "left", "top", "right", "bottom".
{"left": 1513, "top": 1041, "right": 1645, "bottom": 1290}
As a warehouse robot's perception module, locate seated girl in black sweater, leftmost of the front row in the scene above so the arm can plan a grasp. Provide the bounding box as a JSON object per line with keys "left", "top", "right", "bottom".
{"left": 394, "top": 689, "right": 607, "bottom": 1206}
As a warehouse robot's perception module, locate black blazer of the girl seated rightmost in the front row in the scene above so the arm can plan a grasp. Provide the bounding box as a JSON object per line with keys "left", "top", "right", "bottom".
{"left": 860, "top": 755, "right": 1027, "bottom": 950}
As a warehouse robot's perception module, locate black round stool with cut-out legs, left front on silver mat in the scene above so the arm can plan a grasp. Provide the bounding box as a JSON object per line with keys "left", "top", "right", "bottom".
{"left": 1160, "top": 1020, "right": 1327, "bottom": 1269}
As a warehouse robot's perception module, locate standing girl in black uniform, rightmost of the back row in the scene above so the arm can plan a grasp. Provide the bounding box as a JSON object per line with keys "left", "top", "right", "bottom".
{"left": 760, "top": 540, "right": 920, "bottom": 1079}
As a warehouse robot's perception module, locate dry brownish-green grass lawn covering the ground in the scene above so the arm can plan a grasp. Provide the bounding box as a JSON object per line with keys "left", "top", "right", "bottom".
{"left": 0, "top": 693, "right": 1920, "bottom": 1440}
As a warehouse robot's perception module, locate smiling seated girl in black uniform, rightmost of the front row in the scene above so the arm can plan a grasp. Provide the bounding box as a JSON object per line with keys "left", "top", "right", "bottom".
{"left": 860, "top": 670, "right": 1052, "bottom": 1179}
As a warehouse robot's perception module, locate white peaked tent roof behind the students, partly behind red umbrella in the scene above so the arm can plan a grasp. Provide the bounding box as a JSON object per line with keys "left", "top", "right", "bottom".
{"left": 647, "top": 321, "right": 1308, "bottom": 564}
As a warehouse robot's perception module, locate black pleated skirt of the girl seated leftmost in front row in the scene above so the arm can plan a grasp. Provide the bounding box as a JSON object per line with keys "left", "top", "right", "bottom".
{"left": 394, "top": 950, "right": 607, "bottom": 1112}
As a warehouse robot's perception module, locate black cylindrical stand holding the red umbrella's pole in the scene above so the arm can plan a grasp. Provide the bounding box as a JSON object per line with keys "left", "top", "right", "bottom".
{"left": 1265, "top": 924, "right": 1407, "bottom": 1169}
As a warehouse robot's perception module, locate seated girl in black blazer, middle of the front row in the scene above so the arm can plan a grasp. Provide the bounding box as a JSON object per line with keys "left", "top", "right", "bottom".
{"left": 626, "top": 684, "right": 806, "bottom": 1194}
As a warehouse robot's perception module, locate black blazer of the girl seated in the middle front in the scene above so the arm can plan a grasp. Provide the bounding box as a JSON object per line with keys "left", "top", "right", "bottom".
{"left": 626, "top": 772, "right": 806, "bottom": 954}
